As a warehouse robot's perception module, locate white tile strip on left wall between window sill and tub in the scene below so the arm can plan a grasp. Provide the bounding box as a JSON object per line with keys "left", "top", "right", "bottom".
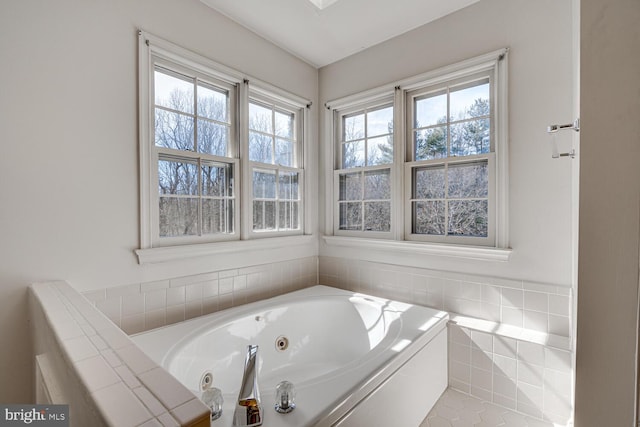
{"left": 83, "top": 257, "right": 318, "bottom": 334}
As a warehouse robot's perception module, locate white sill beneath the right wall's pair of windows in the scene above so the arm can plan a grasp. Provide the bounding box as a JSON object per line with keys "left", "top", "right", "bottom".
{"left": 323, "top": 236, "right": 513, "bottom": 262}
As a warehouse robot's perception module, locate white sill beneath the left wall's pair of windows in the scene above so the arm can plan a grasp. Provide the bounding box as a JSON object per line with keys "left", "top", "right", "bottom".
{"left": 135, "top": 235, "right": 316, "bottom": 264}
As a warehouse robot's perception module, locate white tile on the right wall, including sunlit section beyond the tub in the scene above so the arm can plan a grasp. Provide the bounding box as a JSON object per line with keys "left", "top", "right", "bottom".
{"left": 319, "top": 257, "right": 573, "bottom": 426}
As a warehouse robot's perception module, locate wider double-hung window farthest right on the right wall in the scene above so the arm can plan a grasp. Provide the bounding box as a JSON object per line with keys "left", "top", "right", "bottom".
{"left": 405, "top": 77, "right": 495, "bottom": 245}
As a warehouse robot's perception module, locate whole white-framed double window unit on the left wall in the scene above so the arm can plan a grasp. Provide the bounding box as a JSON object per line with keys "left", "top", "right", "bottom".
{"left": 138, "top": 32, "right": 310, "bottom": 259}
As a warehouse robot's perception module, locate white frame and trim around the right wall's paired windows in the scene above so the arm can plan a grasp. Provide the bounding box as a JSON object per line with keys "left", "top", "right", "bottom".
{"left": 324, "top": 48, "right": 511, "bottom": 261}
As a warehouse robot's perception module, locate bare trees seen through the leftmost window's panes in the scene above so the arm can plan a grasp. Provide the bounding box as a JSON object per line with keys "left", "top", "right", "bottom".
{"left": 154, "top": 89, "right": 233, "bottom": 237}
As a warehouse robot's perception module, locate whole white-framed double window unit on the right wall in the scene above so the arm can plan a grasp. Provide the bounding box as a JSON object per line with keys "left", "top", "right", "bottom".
{"left": 327, "top": 49, "right": 508, "bottom": 251}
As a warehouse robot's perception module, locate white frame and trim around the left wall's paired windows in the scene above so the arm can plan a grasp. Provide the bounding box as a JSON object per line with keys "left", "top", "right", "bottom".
{"left": 135, "top": 30, "right": 313, "bottom": 264}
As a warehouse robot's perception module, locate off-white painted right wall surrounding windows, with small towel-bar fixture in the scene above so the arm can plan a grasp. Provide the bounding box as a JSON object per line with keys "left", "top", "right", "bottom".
{"left": 320, "top": 0, "right": 575, "bottom": 286}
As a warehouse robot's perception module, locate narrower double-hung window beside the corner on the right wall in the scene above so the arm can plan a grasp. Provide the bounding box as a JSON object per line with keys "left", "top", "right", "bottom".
{"left": 334, "top": 102, "right": 393, "bottom": 237}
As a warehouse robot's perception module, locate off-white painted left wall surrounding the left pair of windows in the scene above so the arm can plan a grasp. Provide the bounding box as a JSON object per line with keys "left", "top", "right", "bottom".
{"left": 0, "top": 0, "right": 318, "bottom": 403}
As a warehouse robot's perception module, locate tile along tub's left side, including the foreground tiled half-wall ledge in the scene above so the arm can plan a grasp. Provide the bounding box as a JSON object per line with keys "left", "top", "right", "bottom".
{"left": 30, "top": 257, "right": 318, "bottom": 427}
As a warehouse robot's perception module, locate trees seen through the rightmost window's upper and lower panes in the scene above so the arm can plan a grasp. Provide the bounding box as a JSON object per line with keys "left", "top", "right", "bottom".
{"left": 412, "top": 98, "right": 491, "bottom": 237}
